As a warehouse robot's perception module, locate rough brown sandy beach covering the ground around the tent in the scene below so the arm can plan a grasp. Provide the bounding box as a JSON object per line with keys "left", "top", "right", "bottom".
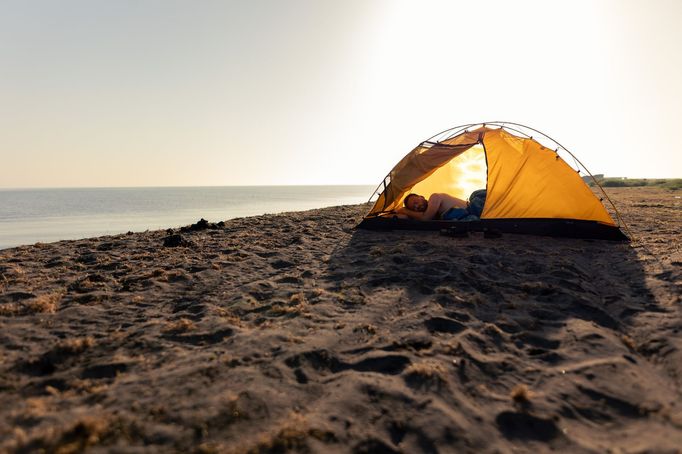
{"left": 0, "top": 188, "right": 682, "bottom": 453}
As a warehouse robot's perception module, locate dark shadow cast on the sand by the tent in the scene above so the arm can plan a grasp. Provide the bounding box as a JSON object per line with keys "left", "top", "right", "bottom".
{"left": 327, "top": 230, "right": 660, "bottom": 333}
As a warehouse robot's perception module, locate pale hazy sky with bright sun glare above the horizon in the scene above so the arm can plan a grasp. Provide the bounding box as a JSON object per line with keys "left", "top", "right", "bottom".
{"left": 0, "top": 0, "right": 682, "bottom": 188}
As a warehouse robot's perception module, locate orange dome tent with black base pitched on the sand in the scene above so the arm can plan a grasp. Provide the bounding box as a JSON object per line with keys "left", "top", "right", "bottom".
{"left": 358, "top": 122, "right": 628, "bottom": 241}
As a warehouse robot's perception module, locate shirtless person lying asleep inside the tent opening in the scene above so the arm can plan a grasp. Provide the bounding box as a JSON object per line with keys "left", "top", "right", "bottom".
{"left": 397, "top": 189, "right": 486, "bottom": 221}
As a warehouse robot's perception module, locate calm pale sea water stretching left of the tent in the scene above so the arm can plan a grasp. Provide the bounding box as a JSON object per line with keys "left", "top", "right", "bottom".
{"left": 0, "top": 186, "right": 374, "bottom": 249}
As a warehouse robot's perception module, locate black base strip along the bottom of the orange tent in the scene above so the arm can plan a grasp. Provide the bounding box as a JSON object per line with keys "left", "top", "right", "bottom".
{"left": 357, "top": 217, "right": 630, "bottom": 241}
